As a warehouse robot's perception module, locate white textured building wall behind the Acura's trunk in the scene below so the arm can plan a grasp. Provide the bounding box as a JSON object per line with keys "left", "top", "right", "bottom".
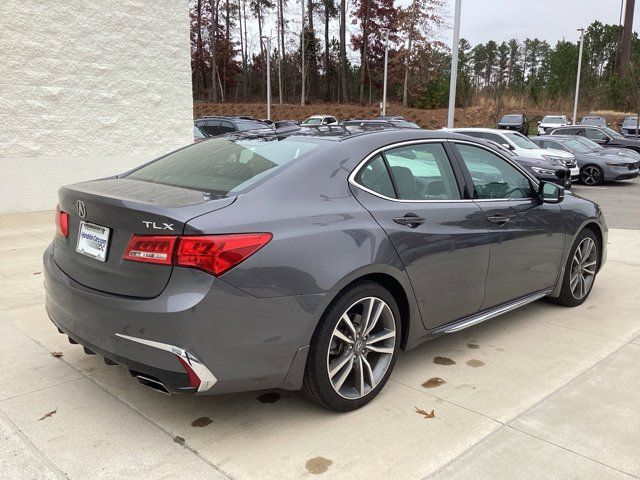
{"left": 0, "top": 0, "right": 193, "bottom": 213}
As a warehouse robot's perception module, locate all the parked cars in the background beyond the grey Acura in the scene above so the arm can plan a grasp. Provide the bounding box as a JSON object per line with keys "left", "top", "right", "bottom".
{"left": 194, "top": 114, "right": 640, "bottom": 188}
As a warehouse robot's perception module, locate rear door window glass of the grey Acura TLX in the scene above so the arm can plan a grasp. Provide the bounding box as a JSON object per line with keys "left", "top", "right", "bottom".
{"left": 384, "top": 143, "right": 460, "bottom": 200}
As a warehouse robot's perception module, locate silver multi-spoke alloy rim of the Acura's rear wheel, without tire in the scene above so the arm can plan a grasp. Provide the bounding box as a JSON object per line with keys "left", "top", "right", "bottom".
{"left": 327, "top": 297, "right": 396, "bottom": 400}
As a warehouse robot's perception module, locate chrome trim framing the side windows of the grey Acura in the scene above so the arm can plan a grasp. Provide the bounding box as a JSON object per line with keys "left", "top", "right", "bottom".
{"left": 348, "top": 138, "right": 540, "bottom": 203}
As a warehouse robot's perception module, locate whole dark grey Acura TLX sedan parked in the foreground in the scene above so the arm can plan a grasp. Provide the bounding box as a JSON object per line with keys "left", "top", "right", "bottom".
{"left": 44, "top": 126, "right": 608, "bottom": 411}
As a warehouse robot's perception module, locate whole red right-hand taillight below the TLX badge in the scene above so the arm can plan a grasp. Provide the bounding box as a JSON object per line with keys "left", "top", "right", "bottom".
{"left": 124, "top": 233, "right": 272, "bottom": 277}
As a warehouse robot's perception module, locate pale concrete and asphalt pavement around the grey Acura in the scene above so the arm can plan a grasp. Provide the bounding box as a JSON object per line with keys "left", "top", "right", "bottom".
{"left": 0, "top": 179, "right": 640, "bottom": 480}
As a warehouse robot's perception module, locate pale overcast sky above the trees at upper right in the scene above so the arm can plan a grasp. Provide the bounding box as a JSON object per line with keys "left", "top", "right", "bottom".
{"left": 442, "top": 0, "right": 640, "bottom": 45}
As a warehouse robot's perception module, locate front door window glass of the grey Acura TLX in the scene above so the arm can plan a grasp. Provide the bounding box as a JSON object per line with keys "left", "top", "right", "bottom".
{"left": 456, "top": 144, "right": 533, "bottom": 199}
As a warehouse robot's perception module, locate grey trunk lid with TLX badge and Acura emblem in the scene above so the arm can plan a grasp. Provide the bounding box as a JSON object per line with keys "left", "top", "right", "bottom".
{"left": 53, "top": 178, "right": 235, "bottom": 298}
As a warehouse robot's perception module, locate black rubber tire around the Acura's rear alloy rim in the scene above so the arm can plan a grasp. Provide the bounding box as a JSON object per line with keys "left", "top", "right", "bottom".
{"left": 302, "top": 281, "right": 402, "bottom": 412}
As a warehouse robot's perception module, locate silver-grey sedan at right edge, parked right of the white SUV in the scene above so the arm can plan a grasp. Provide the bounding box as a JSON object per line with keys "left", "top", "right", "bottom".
{"left": 534, "top": 135, "right": 638, "bottom": 185}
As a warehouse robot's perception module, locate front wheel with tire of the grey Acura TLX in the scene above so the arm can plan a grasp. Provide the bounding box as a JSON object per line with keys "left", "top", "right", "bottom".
{"left": 555, "top": 229, "right": 600, "bottom": 307}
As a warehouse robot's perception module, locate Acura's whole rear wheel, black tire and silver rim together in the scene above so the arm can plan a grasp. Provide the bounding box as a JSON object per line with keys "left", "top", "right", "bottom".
{"left": 302, "top": 282, "right": 400, "bottom": 411}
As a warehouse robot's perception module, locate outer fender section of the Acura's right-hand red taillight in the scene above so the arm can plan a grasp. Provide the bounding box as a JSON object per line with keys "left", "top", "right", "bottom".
{"left": 175, "top": 233, "right": 272, "bottom": 277}
